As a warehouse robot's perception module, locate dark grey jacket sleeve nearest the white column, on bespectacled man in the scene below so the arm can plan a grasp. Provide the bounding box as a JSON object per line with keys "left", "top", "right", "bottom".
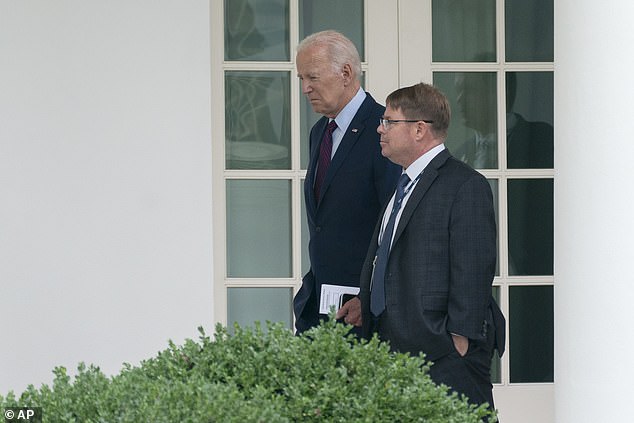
{"left": 447, "top": 174, "right": 497, "bottom": 340}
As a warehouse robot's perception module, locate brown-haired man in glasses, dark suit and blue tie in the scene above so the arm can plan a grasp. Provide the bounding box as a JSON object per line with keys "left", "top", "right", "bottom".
{"left": 342, "top": 83, "right": 504, "bottom": 407}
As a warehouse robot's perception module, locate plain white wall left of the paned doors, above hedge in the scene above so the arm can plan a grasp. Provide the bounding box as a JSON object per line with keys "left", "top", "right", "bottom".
{"left": 0, "top": 0, "right": 213, "bottom": 394}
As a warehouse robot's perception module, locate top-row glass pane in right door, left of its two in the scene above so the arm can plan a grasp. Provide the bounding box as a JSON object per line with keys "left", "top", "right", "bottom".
{"left": 432, "top": 0, "right": 495, "bottom": 62}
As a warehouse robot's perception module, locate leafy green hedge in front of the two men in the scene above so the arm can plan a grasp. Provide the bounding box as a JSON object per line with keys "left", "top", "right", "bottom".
{"left": 0, "top": 322, "right": 495, "bottom": 423}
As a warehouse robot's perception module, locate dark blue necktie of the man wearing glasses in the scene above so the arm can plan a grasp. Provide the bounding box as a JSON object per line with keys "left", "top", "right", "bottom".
{"left": 370, "top": 173, "right": 410, "bottom": 316}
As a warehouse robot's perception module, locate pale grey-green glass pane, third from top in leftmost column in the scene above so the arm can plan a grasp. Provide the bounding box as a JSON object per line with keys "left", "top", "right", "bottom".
{"left": 227, "top": 179, "right": 292, "bottom": 278}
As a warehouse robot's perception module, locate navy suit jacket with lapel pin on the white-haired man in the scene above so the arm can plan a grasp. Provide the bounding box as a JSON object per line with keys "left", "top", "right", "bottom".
{"left": 293, "top": 94, "right": 401, "bottom": 332}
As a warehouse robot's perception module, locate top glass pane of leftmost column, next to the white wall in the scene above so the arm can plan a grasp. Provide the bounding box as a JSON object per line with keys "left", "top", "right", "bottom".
{"left": 225, "top": 0, "right": 290, "bottom": 61}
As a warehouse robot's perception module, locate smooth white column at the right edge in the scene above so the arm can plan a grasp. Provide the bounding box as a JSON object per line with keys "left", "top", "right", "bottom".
{"left": 555, "top": 0, "right": 634, "bottom": 423}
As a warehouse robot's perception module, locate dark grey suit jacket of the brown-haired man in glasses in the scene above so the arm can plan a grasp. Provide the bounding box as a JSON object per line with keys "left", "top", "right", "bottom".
{"left": 360, "top": 149, "right": 504, "bottom": 361}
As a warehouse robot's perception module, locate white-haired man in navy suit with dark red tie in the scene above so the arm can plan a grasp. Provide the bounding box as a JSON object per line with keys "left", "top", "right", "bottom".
{"left": 293, "top": 31, "right": 400, "bottom": 332}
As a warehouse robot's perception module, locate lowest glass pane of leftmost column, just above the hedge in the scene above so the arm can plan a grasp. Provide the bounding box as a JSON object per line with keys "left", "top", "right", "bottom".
{"left": 227, "top": 288, "right": 293, "bottom": 330}
